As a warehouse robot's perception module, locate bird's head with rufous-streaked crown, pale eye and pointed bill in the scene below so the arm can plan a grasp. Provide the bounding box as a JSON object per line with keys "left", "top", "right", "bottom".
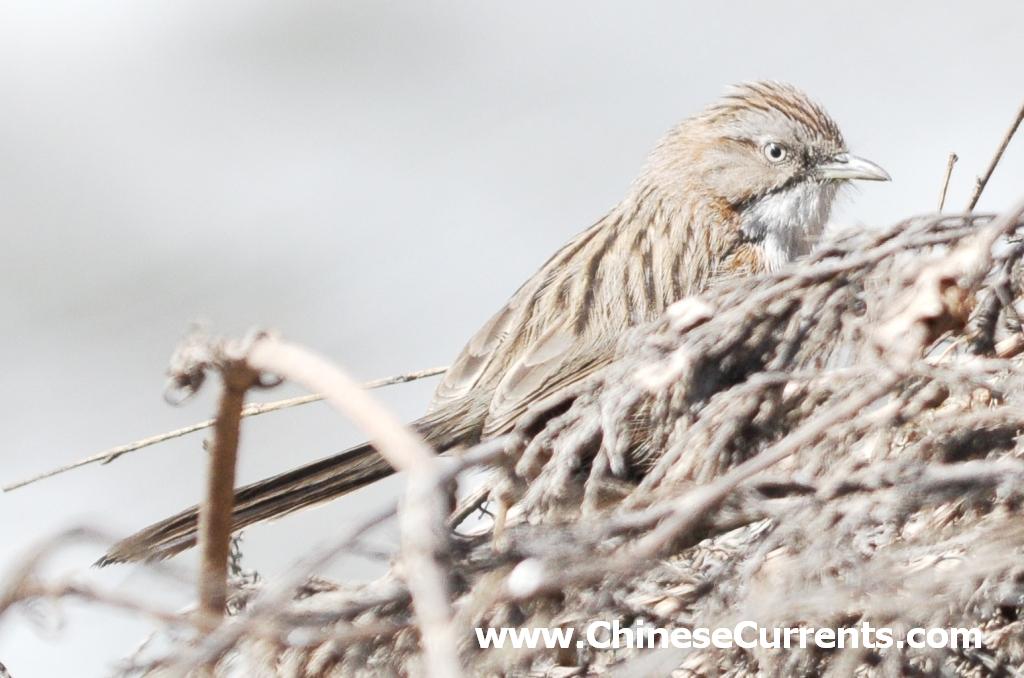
{"left": 648, "top": 82, "right": 890, "bottom": 267}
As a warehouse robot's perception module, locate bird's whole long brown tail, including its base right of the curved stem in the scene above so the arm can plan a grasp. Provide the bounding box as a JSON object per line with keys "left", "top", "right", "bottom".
{"left": 96, "top": 399, "right": 481, "bottom": 566}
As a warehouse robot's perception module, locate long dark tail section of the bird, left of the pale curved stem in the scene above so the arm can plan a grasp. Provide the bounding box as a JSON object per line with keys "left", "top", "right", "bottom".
{"left": 96, "top": 443, "right": 394, "bottom": 566}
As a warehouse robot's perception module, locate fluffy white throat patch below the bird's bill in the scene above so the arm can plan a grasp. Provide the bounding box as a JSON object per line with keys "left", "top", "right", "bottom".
{"left": 742, "top": 180, "right": 838, "bottom": 270}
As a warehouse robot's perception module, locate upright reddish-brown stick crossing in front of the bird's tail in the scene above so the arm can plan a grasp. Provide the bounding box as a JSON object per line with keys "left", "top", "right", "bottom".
{"left": 199, "top": 359, "right": 259, "bottom": 630}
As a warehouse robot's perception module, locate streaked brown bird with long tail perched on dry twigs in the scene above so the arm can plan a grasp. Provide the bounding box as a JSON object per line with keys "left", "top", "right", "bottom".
{"left": 99, "top": 81, "right": 890, "bottom": 564}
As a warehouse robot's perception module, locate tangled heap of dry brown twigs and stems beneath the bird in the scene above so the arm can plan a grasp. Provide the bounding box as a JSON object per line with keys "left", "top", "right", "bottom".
{"left": 6, "top": 106, "right": 1024, "bottom": 676}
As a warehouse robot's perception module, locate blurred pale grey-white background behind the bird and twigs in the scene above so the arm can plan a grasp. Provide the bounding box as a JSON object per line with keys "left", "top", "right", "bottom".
{"left": 0, "top": 0, "right": 1024, "bottom": 678}
